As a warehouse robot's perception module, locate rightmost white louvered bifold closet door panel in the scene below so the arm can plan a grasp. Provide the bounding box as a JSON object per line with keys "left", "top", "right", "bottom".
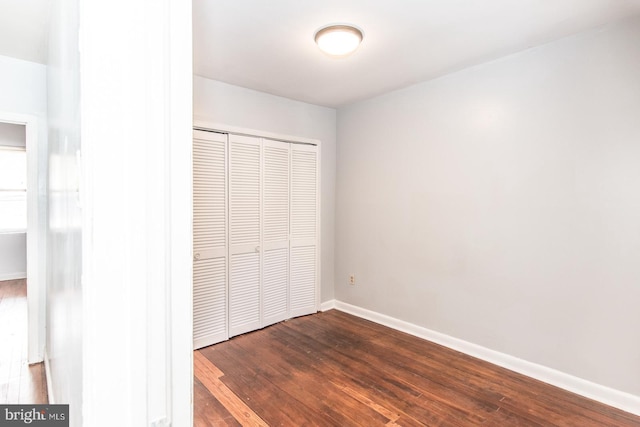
{"left": 289, "top": 144, "right": 319, "bottom": 317}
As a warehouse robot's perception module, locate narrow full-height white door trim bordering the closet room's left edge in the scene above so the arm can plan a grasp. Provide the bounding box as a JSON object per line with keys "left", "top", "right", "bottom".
{"left": 165, "top": 0, "right": 193, "bottom": 427}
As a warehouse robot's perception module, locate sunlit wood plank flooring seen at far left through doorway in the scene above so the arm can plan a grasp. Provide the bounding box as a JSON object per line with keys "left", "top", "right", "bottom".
{"left": 0, "top": 279, "right": 48, "bottom": 404}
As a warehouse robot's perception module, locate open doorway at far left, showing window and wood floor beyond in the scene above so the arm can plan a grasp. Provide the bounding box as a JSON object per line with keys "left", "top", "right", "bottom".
{"left": 0, "top": 112, "right": 47, "bottom": 403}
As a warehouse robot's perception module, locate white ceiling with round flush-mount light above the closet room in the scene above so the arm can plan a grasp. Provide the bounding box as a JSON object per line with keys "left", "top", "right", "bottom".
{"left": 193, "top": 0, "right": 640, "bottom": 107}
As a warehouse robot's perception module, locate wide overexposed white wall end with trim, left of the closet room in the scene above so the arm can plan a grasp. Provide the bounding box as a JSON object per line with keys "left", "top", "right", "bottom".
{"left": 79, "top": 0, "right": 193, "bottom": 427}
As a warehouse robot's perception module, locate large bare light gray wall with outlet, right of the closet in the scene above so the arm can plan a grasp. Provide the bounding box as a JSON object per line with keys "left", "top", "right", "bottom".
{"left": 335, "top": 20, "right": 640, "bottom": 395}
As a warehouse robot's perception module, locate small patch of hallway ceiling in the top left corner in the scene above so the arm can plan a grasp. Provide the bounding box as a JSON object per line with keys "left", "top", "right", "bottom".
{"left": 0, "top": 0, "right": 51, "bottom": 64}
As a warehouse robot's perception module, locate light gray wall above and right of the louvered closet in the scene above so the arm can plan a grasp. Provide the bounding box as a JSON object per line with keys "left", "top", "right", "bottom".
{"left": 193, "top": 76, "right": 336, "bottom": 301}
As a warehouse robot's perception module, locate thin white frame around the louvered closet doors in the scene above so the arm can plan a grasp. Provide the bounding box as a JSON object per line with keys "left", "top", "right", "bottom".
{"left": 193, "top": 118, "right": 322, "bottom": 311}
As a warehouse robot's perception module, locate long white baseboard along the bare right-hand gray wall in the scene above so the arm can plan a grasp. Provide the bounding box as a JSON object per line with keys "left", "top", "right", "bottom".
{"left": 332, "top": 300, "right": 640, "bottom": 415}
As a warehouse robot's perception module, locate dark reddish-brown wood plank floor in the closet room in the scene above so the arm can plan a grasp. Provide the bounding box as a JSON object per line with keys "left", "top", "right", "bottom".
{"left": 194, "top": 310, "right": 640, "bottom": 427}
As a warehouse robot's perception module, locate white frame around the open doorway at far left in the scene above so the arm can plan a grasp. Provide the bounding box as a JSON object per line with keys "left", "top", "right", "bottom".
{"left": 0, "top": 111, "right": 46, "bottom": 364}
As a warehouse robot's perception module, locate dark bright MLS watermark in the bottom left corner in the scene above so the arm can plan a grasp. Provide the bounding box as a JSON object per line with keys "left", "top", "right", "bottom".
{"left": 0, "top": 405, "right": 69, "bottom": 427}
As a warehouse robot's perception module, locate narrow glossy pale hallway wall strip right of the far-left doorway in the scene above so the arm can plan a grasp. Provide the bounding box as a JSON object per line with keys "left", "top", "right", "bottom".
{"left": 45, "top": 0, "right": 80, "bottom": 418}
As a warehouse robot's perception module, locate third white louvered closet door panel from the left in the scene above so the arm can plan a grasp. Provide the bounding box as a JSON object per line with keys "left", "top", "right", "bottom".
{"left": 262, "top": 139, "right": 291, "bottom": 326}
